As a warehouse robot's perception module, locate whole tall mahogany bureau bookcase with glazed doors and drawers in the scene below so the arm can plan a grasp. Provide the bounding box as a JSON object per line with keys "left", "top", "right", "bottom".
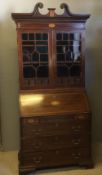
{"left": 12, "top": 3, "right": 93, "bottom": 175}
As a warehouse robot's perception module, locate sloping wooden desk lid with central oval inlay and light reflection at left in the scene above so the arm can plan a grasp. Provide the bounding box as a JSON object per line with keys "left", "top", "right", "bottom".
{"left": 19, "top": 90, "right": 90, "bottom": 117}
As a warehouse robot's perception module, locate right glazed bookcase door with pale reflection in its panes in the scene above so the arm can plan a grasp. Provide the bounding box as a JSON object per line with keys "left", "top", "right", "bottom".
{"left": 55, "top": 31, "right": 82, "bottom": 87}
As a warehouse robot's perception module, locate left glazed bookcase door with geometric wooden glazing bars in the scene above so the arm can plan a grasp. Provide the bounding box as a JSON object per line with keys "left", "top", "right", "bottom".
{"left": 19, "top": 31, "right": 52, "bottom": 89}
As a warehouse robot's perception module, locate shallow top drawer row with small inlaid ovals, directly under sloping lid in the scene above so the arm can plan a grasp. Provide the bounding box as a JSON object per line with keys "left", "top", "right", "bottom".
{"left": 21, "top": 114, "right": 90, "bottom": 127}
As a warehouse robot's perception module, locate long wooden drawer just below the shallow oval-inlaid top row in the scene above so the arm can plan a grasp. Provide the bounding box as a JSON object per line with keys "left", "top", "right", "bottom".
{"left": 21, "top": 123, "right": 90, "bottom": 137}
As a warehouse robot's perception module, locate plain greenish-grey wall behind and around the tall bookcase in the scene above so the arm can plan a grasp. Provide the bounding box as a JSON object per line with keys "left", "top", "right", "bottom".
{"left": 0, "top": 0, "right": 102, "bottom": 150}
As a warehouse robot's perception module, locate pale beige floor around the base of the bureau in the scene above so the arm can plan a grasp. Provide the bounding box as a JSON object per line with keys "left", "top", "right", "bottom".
{"left": 0, "top": 144, "right": 102, "bottom": 175}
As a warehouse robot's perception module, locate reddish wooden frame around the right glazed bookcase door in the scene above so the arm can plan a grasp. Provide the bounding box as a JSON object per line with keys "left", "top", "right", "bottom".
{"left": 52, "top": 27, "right": 85, "bottom": 88}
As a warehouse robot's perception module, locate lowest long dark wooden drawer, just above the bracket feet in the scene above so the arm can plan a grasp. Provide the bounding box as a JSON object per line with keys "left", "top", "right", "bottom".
{"left": 20, "top": 148, "right": 90, "bottom": 168}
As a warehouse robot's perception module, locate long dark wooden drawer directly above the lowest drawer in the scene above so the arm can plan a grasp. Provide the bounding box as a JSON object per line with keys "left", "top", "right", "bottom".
{"left": 21, "top": 134, "right": 90, "bottom": 152}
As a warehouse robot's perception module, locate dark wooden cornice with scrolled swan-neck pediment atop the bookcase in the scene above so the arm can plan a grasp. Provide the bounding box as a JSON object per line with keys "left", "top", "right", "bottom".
{"left": 12, "top": 2, "right": 90, "bottom": 22}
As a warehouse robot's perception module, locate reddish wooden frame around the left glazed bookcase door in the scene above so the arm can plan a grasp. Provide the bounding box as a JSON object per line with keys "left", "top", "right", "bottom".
{"left": 17, "top": 25, "right": 54, "bottom": 90}
